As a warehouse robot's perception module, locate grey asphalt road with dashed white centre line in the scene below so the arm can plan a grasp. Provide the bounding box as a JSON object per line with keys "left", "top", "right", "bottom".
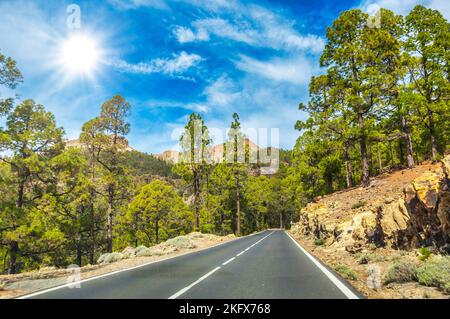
{"left": 25, "top": 230, "right": 360, "bottom": 299}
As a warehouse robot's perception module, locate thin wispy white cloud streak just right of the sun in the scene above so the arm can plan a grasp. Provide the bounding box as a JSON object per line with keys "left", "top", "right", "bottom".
{"left": 107, "top": 51, "right": 202, "bottom": 75}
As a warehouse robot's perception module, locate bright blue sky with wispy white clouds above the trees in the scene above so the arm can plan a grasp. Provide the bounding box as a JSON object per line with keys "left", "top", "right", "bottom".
{"left": 0, "top": 0, "right": 450, "bottom": 153}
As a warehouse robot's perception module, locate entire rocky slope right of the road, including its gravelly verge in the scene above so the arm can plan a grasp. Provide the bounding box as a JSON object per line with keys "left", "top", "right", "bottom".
{"left": 291, "top": 155, "right": 450, "bottom": 298}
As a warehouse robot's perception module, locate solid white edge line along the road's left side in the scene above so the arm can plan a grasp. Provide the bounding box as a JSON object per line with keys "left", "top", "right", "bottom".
{"left": 14, "top": 230, "right": 270, "bottom": 299}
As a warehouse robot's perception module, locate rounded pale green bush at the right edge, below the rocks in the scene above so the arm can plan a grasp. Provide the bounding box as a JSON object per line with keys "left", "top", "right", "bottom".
{"left": 416, "top": 256, "right": 450, "bottom": 293}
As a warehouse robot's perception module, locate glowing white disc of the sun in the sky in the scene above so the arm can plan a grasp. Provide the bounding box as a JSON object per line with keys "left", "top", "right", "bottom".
{"left": 60, "top": 35, "right": 100, "bottom": 75}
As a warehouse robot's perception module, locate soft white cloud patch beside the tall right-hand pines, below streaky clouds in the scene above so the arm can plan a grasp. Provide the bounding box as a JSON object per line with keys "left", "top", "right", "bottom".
{"left": 235, "top": 55, "right": 313, "bottom": 85}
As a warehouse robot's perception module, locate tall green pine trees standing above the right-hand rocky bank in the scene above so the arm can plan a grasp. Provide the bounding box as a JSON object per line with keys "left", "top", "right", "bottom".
{"left": 289, "top": 6, "right": 450, "bottom": 205}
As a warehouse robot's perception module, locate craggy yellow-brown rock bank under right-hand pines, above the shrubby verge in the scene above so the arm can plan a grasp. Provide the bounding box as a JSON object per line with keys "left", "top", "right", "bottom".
{"left": 293, "top": 155, "right": 450, "bottom": 252}
